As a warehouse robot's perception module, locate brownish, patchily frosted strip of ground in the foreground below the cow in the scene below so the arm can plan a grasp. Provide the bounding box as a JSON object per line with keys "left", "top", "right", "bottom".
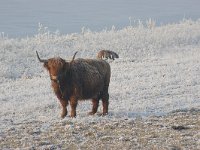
{"left": 0, "top": 109, "right": 200, "bottom": 150}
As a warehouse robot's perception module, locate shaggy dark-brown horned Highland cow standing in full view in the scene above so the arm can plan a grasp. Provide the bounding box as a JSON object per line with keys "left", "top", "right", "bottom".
{"left": 36, "top": 51, "right": 111, "bottom": 118}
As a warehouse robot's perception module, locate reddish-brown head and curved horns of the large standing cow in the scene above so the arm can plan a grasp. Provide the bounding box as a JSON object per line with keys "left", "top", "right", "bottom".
{"left": 36, "top": 51, "right": 77, "bottom": 82}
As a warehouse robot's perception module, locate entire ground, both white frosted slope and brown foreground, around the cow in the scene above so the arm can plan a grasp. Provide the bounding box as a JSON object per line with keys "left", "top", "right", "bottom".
{"left": 0, "top": 20, "right": 200, "bottom": 149}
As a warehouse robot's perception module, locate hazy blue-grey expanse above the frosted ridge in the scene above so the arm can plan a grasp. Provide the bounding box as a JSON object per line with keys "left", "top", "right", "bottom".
{"left": 0, "top": 0, "right": 200, "bottom": 37}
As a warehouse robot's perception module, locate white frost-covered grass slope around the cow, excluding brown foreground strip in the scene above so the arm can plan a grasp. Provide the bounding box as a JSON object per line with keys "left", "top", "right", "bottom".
{"left": 0, "top": 20, "right": 200, "bottom": 135}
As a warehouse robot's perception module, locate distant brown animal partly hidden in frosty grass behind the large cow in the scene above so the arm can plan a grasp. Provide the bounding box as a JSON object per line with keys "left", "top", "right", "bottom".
{"left": 97, "top": 50, "right": 119, "bottom": 60}
